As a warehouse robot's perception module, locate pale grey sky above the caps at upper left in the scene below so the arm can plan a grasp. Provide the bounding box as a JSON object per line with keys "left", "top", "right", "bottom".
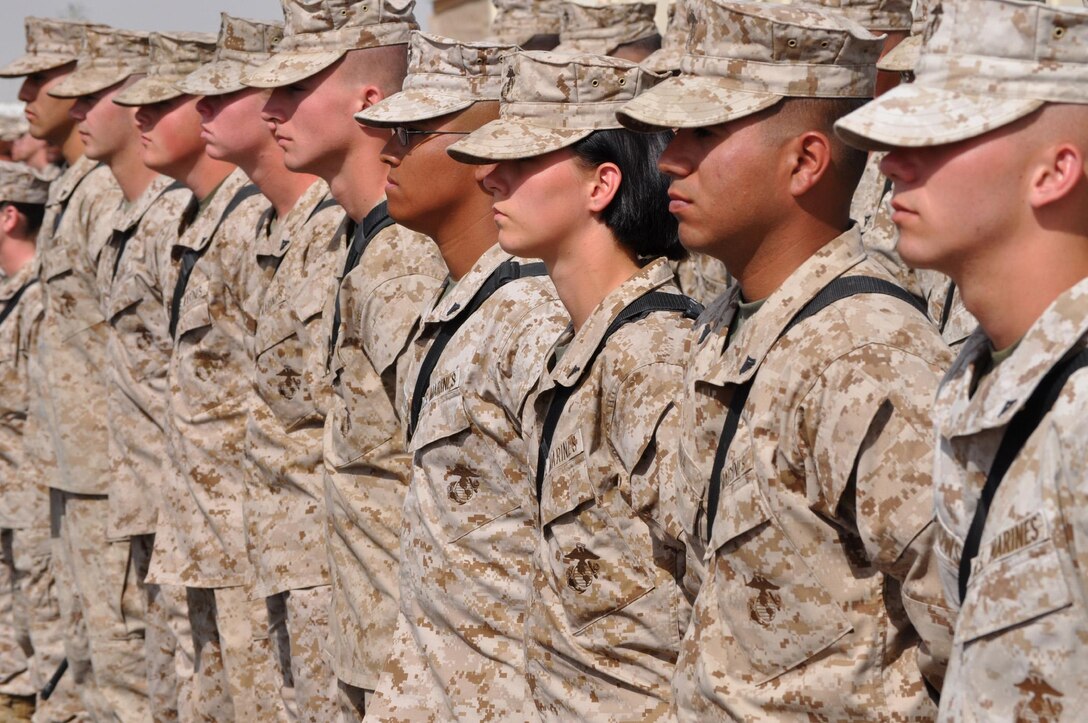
{"left": 0, "top": 0, "right": 431, "bottom": 103}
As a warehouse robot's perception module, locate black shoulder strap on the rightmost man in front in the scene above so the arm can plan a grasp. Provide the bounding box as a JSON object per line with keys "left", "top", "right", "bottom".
{"left": 959, "top": 349, "right": 1088, "bottom": 603}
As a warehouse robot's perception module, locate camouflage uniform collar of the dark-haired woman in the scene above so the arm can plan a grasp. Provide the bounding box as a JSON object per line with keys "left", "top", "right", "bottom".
{"left": 548, "top": 259, "right": 673, "bottom": 387}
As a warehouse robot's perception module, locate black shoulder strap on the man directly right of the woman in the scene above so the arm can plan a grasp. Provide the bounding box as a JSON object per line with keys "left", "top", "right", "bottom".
{"left": 706, "top": 276, "right": 926, "bottom": 541}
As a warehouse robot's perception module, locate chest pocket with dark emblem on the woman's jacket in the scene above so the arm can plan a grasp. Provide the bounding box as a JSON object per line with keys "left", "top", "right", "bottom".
{"left": 541, "top": 431, "right": 657, "bottom": 643}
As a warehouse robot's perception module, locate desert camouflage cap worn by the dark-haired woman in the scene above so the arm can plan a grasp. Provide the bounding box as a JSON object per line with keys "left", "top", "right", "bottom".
{"left": 448, "top": 51, "right": 662, "bottom": 163}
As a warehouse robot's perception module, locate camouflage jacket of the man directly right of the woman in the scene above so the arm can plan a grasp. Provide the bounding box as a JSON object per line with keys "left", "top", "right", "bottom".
{"left": 667, "top": 229, "right": 952, "bottom": 721}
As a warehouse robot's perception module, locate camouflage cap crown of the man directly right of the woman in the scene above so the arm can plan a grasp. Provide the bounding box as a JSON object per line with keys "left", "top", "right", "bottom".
{"left": 680, "top": 0, "right": 883, "bottom": 98}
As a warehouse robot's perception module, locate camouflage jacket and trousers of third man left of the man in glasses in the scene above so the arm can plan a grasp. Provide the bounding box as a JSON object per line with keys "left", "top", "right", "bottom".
{"left": 149, "top": 167, "right": 283, "bottom": 720}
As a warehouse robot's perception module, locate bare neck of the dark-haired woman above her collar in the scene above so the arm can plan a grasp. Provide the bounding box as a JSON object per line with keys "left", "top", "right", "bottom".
{"left": 544, "top": 221, "right": 639, "bottom": 332}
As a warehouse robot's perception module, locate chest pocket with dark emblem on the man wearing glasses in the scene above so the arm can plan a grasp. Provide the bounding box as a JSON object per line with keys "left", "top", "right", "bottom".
{"left": 409, "top": 389, "right": 521, "bottom": 543}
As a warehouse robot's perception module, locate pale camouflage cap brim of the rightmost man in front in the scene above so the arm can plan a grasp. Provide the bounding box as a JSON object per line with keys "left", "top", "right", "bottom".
{"left": 834, "top": 83, "right": 1044, "bottom": 151}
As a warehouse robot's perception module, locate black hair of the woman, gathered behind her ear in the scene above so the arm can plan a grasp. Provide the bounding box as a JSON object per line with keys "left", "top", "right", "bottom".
{"left": 570, "top": 128, "right": 685, "bottom": 259}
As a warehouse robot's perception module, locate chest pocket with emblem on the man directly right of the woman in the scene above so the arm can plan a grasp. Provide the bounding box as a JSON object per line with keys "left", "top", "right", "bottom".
{"left": 709, "top": 466, "right": 853, "bottom": 684}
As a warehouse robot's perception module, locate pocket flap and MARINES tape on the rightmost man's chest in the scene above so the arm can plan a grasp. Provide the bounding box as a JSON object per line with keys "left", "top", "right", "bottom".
{"left": 956, "top": 513, "right": 1073, "bottom": 645}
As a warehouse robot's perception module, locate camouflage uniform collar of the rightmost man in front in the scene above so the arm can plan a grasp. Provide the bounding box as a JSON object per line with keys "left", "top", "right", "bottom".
{"left": 937, "top": 278, "right": 1088, "bottom": 438}
